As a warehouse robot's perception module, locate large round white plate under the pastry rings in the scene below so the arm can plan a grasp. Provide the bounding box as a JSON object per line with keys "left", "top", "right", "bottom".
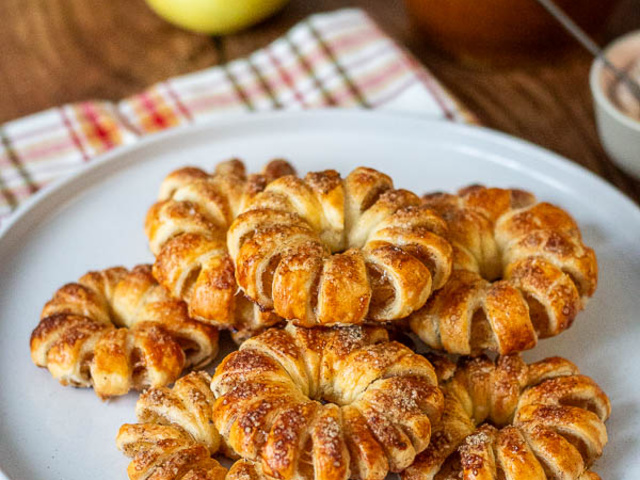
{"left": 0, "top": 111, "right": 640, "bottom": 480}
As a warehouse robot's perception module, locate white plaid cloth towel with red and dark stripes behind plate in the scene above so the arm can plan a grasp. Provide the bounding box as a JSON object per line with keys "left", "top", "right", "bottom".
{"left": 0, "top": 9, "right": 472, "bottom": 222}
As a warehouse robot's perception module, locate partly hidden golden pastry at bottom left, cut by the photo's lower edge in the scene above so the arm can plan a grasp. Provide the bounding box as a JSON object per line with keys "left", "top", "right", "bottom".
{"left": 116, "top": 372, "right": 227, "bottom": 480}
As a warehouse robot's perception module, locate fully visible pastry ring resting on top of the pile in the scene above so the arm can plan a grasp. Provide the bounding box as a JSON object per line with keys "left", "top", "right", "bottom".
{"left": 227, "top": 167, "right": 452, "bottom": 327}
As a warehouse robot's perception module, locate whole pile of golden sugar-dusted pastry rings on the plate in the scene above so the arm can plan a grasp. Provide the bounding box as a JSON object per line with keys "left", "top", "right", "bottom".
{"left": 31, "top": 160, "right": 610, "bottom": 480}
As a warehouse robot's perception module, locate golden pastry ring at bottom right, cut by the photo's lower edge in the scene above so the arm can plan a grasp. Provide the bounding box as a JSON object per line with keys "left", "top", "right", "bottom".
{"left": 401, "top": 354, "right": 611, "bottom": 480}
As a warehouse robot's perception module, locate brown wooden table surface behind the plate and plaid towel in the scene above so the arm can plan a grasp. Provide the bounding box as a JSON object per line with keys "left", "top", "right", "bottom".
{"left": 0, "top": 0, "right": 640, "bottom": 201}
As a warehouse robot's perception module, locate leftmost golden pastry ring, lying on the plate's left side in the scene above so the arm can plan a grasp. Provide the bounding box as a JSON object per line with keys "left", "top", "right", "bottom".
{"left": 30, "top": 265, "right": 218, "bottom": 399}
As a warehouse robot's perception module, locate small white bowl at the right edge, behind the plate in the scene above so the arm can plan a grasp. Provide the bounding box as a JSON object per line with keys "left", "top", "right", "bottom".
{"left": 589, "top": 30, "right": 640, "bottom": 178}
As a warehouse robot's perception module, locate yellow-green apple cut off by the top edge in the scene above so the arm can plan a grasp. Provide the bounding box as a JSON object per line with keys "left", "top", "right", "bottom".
{"left": 146, "top": 0, "right": 288, "bottom": 35}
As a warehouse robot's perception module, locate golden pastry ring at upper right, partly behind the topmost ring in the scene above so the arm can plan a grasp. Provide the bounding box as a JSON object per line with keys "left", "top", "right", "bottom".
{"left": 410, "top": 186, "right": 598, "bottom": 355}
